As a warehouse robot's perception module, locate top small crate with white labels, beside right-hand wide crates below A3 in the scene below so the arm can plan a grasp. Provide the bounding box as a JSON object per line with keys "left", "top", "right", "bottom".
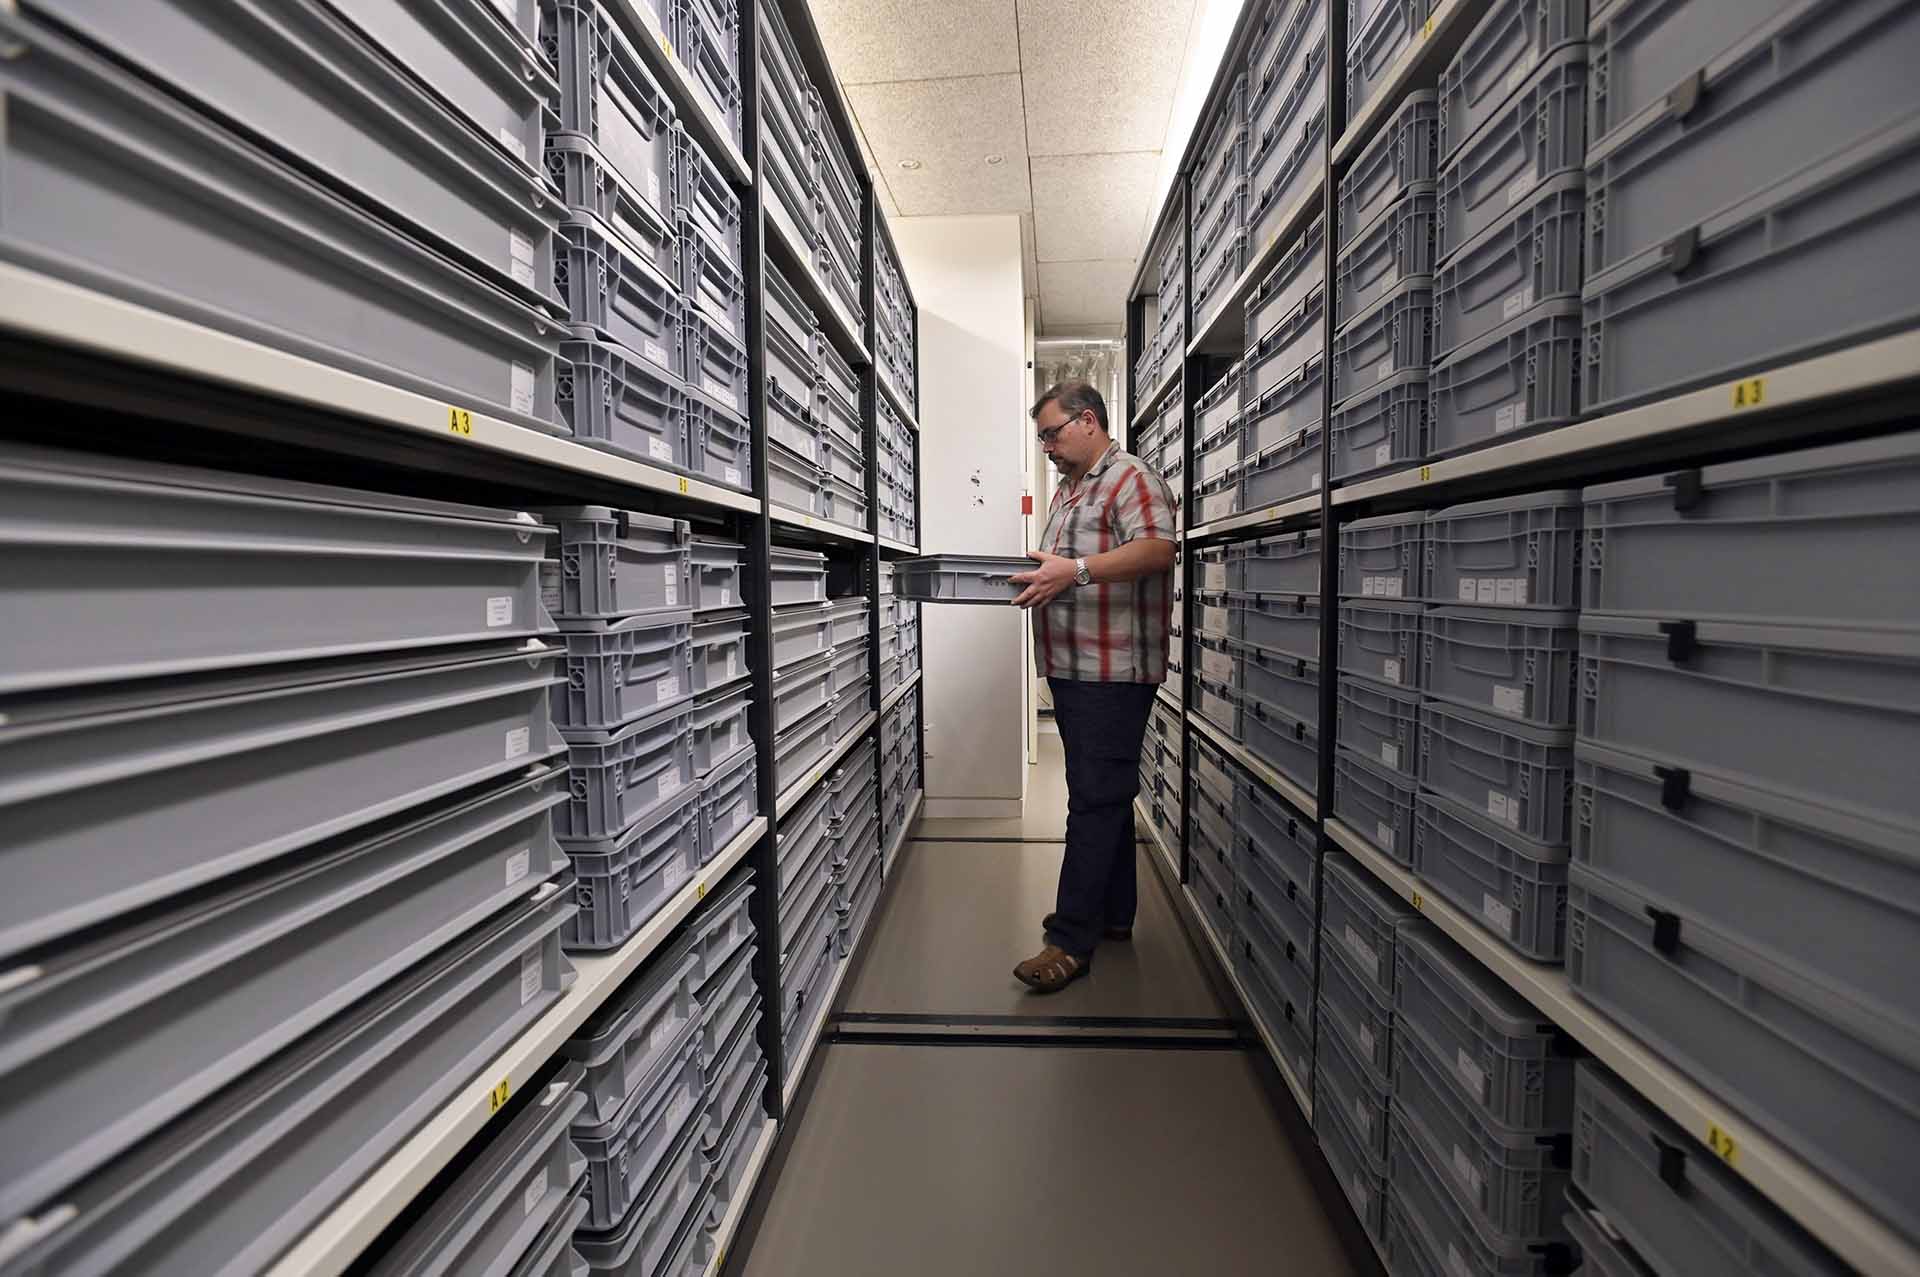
{"left": 1421, "top": 488, "right": 1582, "bottom": 611}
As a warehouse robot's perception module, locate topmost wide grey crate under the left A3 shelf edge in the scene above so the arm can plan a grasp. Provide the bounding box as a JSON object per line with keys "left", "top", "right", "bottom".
{"left": 0, "top": 447, "right": 559, "bottom": 691}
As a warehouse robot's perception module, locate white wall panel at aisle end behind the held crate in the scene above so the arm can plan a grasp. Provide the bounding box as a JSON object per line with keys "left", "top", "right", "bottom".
{"left": 889, "top": 215, "right": 1029, "bottom": 816}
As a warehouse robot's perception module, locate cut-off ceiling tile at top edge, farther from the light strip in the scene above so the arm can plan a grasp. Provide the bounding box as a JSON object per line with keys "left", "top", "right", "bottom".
{"left": 812, "top": 0, "right": 1020, "bottom": 84}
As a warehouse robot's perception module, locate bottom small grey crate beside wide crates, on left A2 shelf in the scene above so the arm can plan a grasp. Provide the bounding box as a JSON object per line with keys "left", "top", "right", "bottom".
{"left": 563, "top": 783, "right": 701, "bottom": 952}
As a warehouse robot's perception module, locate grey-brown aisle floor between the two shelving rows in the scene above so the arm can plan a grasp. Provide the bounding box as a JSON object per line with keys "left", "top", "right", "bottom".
{"left": 743, "top": 737, "right": 1359, "bottom": 1277}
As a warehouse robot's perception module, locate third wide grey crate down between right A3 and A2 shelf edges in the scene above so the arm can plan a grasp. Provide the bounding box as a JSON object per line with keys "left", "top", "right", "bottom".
{"left": 1572, "top": 741, "right": 1920, "bottom": 1024}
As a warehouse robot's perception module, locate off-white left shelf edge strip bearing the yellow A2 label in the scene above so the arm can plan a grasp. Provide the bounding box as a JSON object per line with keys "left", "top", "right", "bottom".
{"left": 267, "top": 816, "right": 766, "bottom": 1277}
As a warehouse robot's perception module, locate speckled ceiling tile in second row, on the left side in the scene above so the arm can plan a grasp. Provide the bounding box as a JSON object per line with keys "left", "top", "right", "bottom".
{"left": 847, "top": 75, "right": 1033, "bottom": 217}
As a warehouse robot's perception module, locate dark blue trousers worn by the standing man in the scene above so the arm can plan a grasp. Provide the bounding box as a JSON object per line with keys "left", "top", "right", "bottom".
{"left": 1046, "top": 678, "right": 1158, "bottom": 958}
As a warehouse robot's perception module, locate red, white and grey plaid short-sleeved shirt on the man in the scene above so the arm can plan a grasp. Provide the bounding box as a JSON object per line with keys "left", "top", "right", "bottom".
{"left": 1033, "top": 444, "right": 1177, "bottom": 684}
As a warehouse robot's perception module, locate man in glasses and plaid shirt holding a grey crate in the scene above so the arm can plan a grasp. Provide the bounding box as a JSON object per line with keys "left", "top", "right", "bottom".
{"left": 1014, "top": 382, "right": 1177, "bottom": 993}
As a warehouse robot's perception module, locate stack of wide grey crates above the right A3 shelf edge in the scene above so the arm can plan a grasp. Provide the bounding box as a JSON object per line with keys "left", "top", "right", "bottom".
{"left": 1580, "top": 0, "right": 1920, "bottom": 413}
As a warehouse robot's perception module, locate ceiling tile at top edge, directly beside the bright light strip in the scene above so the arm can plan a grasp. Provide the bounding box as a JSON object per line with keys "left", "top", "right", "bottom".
{"left": 1020, "top": 0, "right": 1194, "bottom": 156}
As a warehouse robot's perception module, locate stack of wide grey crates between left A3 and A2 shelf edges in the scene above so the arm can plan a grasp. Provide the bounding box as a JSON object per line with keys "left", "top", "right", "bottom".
{"left": 0, "top": 447, "right": 574, "bottom": 1271}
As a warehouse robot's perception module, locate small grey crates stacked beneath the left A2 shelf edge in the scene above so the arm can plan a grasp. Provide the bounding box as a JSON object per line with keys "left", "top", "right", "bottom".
{"left": 563, "top": 874, "right": 766, "bottom": 1273}
